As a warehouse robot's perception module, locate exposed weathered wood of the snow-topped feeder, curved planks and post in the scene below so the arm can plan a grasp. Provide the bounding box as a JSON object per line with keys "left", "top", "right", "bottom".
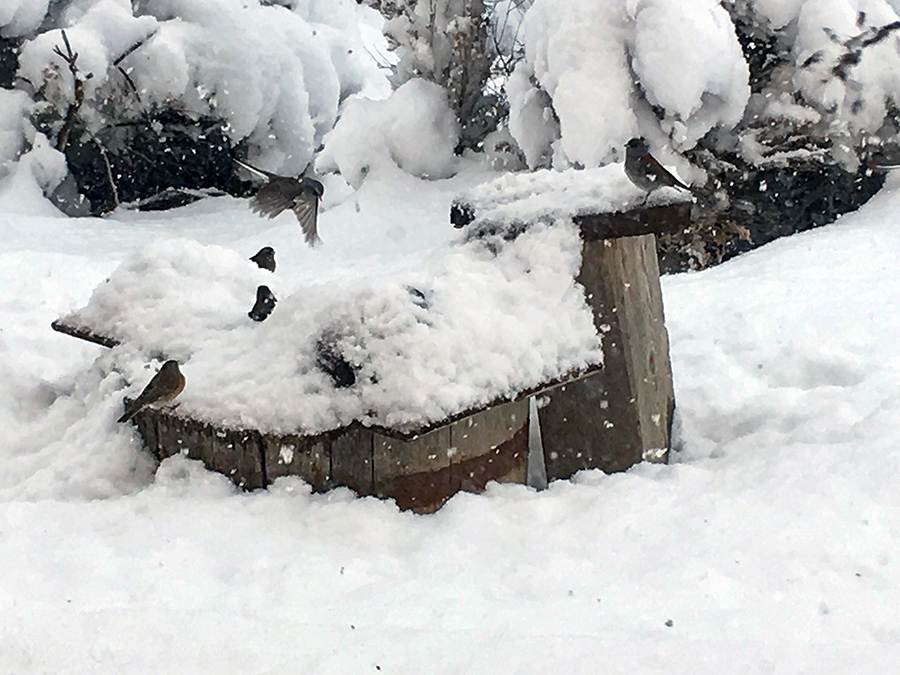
{"left": 53, "top": 173, "right": 690, "bottom": 512}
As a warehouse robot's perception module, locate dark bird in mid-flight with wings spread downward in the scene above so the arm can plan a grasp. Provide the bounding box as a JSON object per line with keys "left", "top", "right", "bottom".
{"left": 234, "top": 159, "right": 325, "bottom": 246}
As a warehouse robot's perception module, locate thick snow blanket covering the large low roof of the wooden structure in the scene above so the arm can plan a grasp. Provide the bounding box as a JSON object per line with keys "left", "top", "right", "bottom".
{"left": 64, "top": 219, "right": 602, "bottom": 434}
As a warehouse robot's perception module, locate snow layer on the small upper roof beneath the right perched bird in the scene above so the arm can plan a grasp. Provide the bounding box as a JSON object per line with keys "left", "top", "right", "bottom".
{"left": 455, "top": 164, "right": 691, "bottom": 235}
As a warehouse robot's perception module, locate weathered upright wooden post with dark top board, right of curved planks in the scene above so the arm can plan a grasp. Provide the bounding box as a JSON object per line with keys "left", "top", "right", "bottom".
{"left": 541, "top": 205, "right": 690, "bottom": 480}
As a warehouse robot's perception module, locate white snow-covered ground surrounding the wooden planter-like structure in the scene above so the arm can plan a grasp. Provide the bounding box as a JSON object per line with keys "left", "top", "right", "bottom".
{"left": 0, "top": 168, "right": 900, "bottom": 675}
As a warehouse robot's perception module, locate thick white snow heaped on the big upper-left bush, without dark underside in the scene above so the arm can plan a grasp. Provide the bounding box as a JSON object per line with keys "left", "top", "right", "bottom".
{"left": 19, "top": 0, "right": 379, "bottom": 173}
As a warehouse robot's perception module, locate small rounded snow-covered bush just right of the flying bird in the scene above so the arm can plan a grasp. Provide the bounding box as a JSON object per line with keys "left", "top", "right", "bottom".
{"left": 316, "top": 79, "right": 459, "bottom": 187}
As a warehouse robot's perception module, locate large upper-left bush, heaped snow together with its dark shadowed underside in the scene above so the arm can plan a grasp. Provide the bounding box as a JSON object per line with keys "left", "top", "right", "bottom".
{"left": 0, "top": 0, "right": 390, "bottom": 213}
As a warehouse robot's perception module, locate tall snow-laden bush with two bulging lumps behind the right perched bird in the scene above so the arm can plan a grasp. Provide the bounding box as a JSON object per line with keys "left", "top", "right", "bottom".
{"left": 509, "top": 0, "right": 750, "bottom": 166}
